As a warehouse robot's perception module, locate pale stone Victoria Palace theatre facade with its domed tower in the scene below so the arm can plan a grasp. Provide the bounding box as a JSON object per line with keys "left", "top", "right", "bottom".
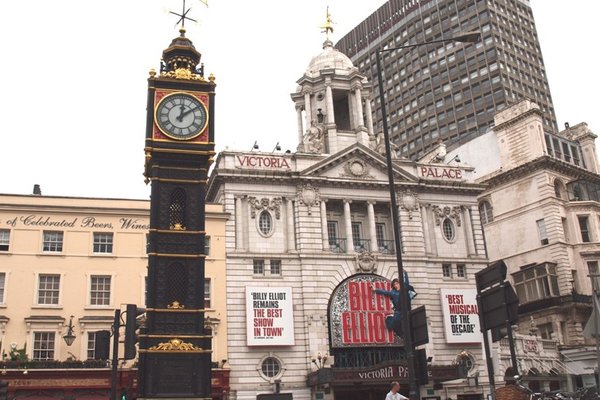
{"left": 207, "top": 36, "right": 487, "bottom": 400}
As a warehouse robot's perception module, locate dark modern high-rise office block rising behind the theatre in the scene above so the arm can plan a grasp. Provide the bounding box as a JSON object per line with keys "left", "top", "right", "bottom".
{"left": 336, "top": 0, "right": 557, "bottom": 158}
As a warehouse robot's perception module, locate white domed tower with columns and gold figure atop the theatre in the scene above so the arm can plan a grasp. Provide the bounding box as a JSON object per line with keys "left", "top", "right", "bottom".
{"left": 291, "top": 12, "right": 375, "bottom": 154}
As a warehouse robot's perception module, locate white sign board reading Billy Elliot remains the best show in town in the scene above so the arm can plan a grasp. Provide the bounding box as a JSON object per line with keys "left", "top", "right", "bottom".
{"left": 246, "top": 287, "right": 294, "bottom": 346}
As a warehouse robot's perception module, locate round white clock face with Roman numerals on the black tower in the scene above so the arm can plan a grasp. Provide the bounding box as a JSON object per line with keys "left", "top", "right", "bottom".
{"left": 155, "top": 93, "right": 208, "bottom": 140}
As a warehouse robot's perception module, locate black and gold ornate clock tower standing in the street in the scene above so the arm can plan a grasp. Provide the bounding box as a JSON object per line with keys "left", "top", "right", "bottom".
{"left": 138, "top": 27, "right": 215, "bottom": 399}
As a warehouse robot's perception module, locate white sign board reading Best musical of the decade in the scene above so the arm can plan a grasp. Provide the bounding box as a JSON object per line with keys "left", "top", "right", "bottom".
{"left": 440, "top": 289, "right": 482, "bottom": 343}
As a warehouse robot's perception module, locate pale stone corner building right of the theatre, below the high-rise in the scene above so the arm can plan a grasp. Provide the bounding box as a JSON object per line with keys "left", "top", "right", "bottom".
{"left": 447, "top": 100, "right": 600, "bottom": 388}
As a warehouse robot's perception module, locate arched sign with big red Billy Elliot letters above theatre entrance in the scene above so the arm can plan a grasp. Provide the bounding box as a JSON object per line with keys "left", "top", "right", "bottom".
{"left": 329, "top": 274, "right": 402, "bottom": 347}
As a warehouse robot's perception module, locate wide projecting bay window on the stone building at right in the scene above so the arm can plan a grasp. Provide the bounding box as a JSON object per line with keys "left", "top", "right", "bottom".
{"left": 513, "top": 263, "right": 560, "bottom": 304}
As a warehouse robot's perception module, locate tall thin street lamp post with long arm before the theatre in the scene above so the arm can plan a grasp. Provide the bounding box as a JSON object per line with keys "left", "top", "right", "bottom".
{"left": 376, "top": 32, "right": 481, "bottom": 400}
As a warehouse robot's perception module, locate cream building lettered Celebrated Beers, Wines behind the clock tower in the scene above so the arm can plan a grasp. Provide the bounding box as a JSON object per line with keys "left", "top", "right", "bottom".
{"left": 0, "top": 194, "right": 227, "bottom": 366}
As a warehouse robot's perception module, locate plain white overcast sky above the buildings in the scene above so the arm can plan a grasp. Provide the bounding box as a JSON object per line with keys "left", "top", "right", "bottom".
{"left": 0, "top": 0, "right": 600, "bottom": 198}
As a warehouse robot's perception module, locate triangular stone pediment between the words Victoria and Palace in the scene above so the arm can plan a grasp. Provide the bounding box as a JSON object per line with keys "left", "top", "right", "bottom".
{"left": 300, "top": 144, "right": 418, "bottom": 183}
